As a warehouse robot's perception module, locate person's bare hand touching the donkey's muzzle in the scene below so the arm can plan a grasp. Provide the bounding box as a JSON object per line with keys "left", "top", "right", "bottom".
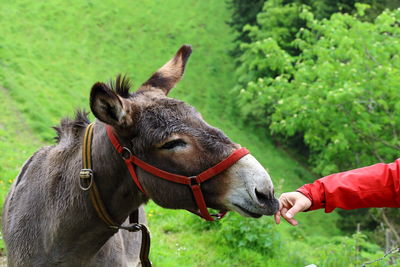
{"left": 274, "top": 192, "right": 311, "bottom": 226}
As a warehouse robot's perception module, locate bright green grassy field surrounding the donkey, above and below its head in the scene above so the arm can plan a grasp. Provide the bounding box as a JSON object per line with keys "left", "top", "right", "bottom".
{"left": 0, "top": 0, "right": 394, "bottom": 266}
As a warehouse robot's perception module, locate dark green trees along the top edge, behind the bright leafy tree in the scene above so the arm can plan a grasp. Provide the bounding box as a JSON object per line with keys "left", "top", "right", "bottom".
{"left": 227, "top": 0, "right": 400, "bottom": 57}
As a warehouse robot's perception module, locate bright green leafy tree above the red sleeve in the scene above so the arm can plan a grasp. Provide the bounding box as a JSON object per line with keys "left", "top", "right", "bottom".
{"left": 238, "top": 4, "right": 400, "bottom": 174}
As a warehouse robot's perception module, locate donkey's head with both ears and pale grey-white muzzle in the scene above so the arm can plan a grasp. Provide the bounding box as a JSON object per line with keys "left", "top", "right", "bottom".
{"left": 90, "top": 45, "right": 278, "bottom": 217}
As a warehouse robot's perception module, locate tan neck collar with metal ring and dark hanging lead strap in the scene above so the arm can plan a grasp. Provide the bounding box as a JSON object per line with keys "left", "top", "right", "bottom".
{"left": 79, "top": 122, "right": 151, "bottom": 267}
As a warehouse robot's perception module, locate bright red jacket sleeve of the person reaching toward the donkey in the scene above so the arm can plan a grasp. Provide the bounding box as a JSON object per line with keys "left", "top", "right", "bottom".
{"left": 297, "top": 159, "right": 400, "bottom": 212}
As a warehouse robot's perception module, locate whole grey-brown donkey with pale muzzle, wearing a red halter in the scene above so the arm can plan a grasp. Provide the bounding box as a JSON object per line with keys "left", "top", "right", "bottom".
{"left": 3, "top": 45, "right": 278, "bottom": 266}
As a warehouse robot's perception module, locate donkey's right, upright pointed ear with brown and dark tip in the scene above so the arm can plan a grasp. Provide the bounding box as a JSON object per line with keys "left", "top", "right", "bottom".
{"left": 138, "top": 45, "right": 192, "bottom": 95}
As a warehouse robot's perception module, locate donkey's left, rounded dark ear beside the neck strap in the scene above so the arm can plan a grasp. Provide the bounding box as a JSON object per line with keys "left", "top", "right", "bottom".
{"left": 90, "top": 82, "right": 125, "bottom": 126}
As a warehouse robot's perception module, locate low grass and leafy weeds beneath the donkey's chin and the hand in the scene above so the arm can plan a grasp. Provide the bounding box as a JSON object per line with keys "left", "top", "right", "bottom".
{"left": 147, "top": 203, "right": 387, "bottom": 267}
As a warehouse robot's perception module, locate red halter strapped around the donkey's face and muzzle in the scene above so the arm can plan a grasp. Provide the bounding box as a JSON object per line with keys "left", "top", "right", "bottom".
{"left": 106, "top": 125, "right": 249, "bottom": 221}
